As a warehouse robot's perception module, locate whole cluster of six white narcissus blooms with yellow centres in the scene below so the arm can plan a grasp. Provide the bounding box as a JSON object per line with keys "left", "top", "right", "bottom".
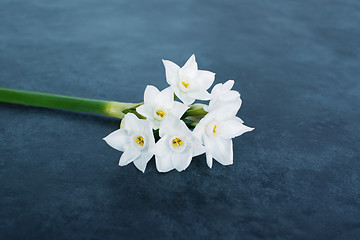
{"left": 104, "top": 55, "right": 254, "bottom": 172}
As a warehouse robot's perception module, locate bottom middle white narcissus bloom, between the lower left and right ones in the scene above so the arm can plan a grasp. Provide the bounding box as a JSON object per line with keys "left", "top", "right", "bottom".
{"left": 154, "top": 117, "right": 205, "bottom": 172}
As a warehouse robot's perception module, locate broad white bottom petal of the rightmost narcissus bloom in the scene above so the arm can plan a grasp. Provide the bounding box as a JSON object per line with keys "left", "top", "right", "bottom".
{"left": 204, "top": 137, "right": 233, "bottom": 165}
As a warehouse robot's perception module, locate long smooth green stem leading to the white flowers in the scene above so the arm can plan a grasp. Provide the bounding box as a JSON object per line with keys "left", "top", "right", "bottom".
{"left": 0, "top": 88, "right": 142, "bottom": 118}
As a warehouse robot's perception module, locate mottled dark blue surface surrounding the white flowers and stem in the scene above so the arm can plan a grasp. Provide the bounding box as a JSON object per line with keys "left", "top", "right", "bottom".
{"left": 0, "top": 0, "right": 360, "bottom": 239}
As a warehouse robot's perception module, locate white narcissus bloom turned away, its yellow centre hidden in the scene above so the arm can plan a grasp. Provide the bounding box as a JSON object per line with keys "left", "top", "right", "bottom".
{"left": 204, "top": 80, "right": 242, "bottom": 112}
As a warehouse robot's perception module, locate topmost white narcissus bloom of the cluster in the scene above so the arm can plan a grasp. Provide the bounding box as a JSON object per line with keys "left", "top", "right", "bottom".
{"left": 163, "top": 55, "right": 215, "bottom": 105}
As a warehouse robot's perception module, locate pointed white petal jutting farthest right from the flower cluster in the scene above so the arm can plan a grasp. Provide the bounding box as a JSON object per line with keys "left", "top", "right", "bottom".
{"left": 221, "top": 117, "right": 254, "bottom": 138}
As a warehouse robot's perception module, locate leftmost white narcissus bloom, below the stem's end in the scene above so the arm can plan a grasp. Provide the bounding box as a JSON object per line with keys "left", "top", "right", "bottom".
{"left": 104, "top": 113, "right": 155, "bottom": 172}
